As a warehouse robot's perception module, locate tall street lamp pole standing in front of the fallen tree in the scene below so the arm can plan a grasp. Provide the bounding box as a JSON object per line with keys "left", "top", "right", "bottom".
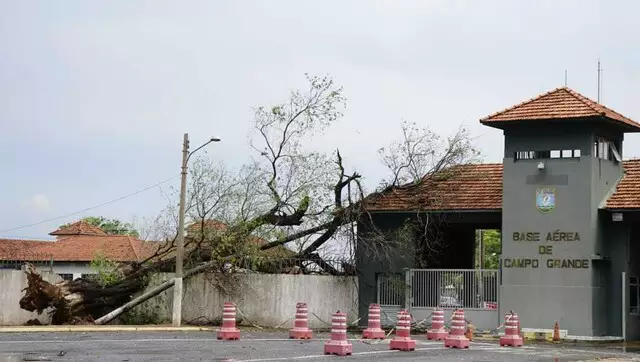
{"left": 173, "top": 133, "right": 220, "bottom": 327}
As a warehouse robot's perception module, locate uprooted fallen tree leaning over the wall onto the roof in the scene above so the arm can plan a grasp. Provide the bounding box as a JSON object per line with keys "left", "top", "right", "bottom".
{"left": 20, "top": 77, "right": 475, "bottom": 324}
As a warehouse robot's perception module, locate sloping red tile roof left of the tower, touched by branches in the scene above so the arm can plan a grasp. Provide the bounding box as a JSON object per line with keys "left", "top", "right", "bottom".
{"left": 367, "top": 164, "right": 502, "bottom": 211}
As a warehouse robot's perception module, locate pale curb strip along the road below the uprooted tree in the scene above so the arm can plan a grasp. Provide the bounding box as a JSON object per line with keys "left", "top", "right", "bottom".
{"left": 0, "top": 326, "right": 218, "bottom": 333}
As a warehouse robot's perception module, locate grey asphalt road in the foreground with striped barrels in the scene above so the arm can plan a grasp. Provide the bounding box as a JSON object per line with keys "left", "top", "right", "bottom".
{"left": 0, "top": 332, "right": 640, "bottom": 362}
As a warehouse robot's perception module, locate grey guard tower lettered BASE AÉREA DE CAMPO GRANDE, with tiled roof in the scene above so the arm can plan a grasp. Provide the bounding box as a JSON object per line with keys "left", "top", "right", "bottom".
{"left": 480, "top": 87, "right": 640, "bottom": 336}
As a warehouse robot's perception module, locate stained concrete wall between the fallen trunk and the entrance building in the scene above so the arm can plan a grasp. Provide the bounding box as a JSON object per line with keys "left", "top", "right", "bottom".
{"left": 137, "top": 274, "right": 358, "bottom": 328}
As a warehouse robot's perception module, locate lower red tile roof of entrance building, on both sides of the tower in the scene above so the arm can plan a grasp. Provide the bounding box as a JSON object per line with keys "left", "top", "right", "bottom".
{"left": 367, "top": 159, "right": 640, "bottom": 212}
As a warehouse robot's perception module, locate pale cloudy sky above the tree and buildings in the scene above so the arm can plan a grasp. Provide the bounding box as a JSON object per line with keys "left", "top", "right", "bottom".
{"left": 0, "top": 0, "right": 640, "bottom": 238}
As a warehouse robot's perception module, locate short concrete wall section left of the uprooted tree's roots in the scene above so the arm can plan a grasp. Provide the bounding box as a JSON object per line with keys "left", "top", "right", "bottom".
{"left": 0, "top": 270, "right": 62, "bottom": 326}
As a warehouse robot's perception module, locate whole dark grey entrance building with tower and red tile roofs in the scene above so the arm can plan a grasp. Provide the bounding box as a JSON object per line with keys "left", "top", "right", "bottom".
{"left": 356, "top": 87, "right": 640, "bottom": 340}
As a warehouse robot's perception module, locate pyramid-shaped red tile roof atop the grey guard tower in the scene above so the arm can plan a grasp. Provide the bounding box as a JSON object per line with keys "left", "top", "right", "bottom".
{"left": 480, "top": 87, "right": 640, "bottom": 131}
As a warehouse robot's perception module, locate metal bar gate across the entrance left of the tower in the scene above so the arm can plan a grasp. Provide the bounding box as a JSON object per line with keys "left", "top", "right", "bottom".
{"left": 377, "top": 269, "right": 500, "bottom": 330}
